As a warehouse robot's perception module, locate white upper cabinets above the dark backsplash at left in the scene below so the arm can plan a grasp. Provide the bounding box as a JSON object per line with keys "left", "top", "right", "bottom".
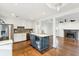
{"left": 6, "top": 19, "right": 33, "bottom": 28}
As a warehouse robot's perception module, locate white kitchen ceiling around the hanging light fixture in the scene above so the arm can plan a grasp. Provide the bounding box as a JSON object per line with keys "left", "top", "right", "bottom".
{"left": 0, "top": 3, "right": 79, "bottom": 20}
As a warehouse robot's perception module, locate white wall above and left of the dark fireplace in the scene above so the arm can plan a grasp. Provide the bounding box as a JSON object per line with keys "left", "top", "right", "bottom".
{"left": 57, "top": 22, "right": 79, "bottom": 37}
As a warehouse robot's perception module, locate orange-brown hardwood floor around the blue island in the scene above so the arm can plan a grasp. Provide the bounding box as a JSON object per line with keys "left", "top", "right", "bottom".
{"left": 13, "top": 38, "right": 79, "bottom": 56}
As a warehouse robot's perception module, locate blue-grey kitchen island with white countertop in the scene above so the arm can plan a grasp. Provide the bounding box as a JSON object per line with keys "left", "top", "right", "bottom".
{"left": 30, "top": 33, "right": 49, "bottom": 52}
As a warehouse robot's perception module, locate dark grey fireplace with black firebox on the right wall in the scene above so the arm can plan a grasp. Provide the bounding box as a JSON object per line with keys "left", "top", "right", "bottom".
{"left": 64, "top": 30, "right": 78, "bottom": 40}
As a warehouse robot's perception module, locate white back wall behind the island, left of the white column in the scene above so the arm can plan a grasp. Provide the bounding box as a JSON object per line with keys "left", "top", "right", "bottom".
{"left": 35, "top": 19, "right": 53, "bottom": 35}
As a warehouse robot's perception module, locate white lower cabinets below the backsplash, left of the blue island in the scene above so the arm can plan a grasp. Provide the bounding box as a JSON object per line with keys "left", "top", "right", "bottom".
{"left": 14, "top": 33, "right": 27, "bottom": 42}
